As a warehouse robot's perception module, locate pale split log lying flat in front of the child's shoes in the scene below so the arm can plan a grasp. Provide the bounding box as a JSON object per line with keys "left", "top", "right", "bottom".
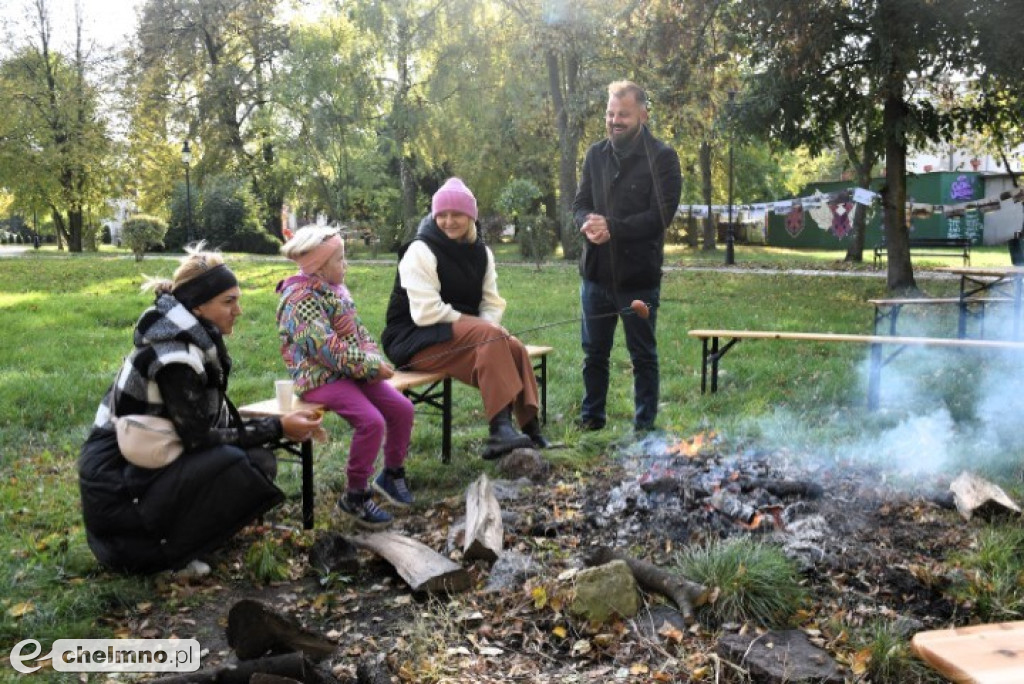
{"left": 352, "top": 532, "right": 472, "bottom": 594}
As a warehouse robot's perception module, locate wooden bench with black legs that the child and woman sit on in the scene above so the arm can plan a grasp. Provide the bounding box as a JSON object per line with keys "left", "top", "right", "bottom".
{"left": 239, "top": 344, "right": 554, "bottom": 529}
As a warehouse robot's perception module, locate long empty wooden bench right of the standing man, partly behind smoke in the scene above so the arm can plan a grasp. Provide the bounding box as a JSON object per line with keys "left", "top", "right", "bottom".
{"left": 687, "top": 330, "right": 1024, "bottom": 411}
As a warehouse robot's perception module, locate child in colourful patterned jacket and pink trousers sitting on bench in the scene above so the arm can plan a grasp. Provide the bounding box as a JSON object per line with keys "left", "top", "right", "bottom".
{"left": 278, "top": 225, "right": 414, "bottom": 528}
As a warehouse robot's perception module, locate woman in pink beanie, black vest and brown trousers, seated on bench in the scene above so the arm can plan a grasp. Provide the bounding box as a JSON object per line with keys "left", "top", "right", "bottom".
{"left": 381, "top": 178, "right": 550, "bottom": 460}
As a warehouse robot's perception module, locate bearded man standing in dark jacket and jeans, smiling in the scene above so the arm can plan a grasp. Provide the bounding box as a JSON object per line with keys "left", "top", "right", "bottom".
{"left": 572, "top": 81, "right": 683, "bottom": 432}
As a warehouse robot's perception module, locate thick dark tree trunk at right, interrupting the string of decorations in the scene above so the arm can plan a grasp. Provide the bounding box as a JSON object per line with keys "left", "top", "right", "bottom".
{"left": 882, "top": 87, "right": 918, "bottom": 294}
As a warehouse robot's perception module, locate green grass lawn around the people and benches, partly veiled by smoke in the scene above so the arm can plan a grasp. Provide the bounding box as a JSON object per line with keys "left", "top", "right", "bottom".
{"left": 0, "top": 246, "right": 1024, "bottom": 680}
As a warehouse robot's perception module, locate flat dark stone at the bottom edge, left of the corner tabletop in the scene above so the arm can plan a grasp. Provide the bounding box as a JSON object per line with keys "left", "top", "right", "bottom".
{"left": 715, "top": 630, "right": 846, "bottom": 684}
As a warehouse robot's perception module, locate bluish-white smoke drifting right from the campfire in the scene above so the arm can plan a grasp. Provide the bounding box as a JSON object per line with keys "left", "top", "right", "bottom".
{"left": 744, "top": 305, "right": 1024, "bottom": 488}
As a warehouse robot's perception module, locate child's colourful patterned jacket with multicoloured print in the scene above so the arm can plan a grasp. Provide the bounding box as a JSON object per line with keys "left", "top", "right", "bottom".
{"left": 278, "top": 274, "right": 386, "bottom": 395}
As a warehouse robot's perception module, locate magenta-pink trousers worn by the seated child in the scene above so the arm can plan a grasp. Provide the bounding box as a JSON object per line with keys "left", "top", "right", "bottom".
{"left": 302, "top": 378, "right": 414, "bottom": 491}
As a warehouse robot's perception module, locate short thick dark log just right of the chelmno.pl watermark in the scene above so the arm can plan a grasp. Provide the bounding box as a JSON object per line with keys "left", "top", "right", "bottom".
{"left": 227, "top": 599, "right": 338, "bottom": 660}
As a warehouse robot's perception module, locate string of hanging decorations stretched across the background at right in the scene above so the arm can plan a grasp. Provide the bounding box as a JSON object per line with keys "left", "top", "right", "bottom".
{"left": 677, "top": 187, "right": 1024, "bottom": 227}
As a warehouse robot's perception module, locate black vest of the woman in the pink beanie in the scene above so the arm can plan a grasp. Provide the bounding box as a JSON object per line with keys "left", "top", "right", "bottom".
{"left": 381, "top": 216, "right": 487, "bottom": 367}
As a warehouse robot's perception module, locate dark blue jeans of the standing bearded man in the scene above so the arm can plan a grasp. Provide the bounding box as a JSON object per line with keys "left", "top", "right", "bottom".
{"left": 580, "top": 281, "right": 660, "bottom": 430}
